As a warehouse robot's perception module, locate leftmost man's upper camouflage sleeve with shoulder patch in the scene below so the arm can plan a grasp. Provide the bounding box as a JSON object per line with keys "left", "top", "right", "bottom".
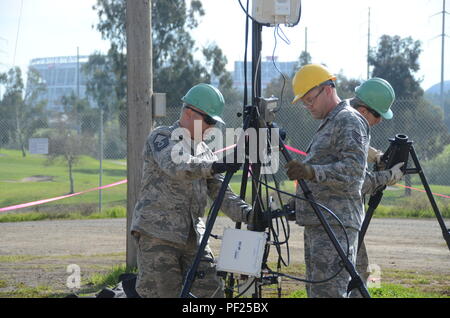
{"left": 145, "top": 131, "right": 213, "bottom": 180}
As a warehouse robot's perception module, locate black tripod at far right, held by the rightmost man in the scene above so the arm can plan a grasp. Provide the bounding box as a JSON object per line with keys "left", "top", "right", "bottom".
{"left": 358, "top": 134, "right": 450, "bottom": 250}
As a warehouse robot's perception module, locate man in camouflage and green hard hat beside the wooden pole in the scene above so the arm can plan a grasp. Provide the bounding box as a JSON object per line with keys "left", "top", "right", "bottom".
{"left": 131, "top": 84, "right": 251, "bottom": 298}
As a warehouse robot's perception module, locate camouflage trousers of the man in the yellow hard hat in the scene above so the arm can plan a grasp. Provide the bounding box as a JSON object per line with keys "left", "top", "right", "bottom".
{"left": 304, "top": 225, "right": 358, "bottom": 298}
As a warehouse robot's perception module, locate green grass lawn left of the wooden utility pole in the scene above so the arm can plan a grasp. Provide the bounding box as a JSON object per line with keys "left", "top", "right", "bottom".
{"left": 0, "top": 149, "right": 127, "bottom": 214}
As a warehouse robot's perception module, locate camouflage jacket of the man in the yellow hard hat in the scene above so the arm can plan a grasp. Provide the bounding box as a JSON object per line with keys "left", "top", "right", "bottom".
{"left": 295, "top": 101, "right": 370, "bottom": 230}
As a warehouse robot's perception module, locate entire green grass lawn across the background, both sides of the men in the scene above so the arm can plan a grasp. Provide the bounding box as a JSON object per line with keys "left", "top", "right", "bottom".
{"left": 0, "top": 149, "right": 450, "bottom": 222}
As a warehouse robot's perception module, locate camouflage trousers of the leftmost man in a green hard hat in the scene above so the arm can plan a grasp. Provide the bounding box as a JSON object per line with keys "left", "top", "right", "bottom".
{"left": 136, "top": 230, "right": 224, "bottom": 298}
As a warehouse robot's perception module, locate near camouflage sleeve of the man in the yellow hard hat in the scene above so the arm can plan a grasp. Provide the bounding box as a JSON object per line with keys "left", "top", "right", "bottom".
{"left": 312, "top": 116, "right": 370, "bottom": 188}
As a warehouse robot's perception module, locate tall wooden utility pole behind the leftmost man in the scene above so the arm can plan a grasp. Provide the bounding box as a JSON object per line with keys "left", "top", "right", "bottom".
{"left": 126, "top": 0, "right": 153, "bottom": 267}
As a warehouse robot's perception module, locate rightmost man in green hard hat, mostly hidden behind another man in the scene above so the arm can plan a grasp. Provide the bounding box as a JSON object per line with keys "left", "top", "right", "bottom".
{"left": 350, "top": 77, "right": 404, "bottom": 298}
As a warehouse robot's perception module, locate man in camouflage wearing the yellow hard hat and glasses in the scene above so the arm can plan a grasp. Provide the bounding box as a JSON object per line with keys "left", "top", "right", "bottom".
{"left": 286, "top": 64, "right": 370, "bottom": 298}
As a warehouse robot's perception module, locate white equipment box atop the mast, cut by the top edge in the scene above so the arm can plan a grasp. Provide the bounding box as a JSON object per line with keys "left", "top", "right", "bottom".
{"left": 252, "top": 0, "right": 301, "bottom": 25}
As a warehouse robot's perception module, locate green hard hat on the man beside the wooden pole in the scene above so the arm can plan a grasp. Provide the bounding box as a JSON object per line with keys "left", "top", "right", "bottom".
{"left": 181, "top": 83, "right": 225, "bottom": 124}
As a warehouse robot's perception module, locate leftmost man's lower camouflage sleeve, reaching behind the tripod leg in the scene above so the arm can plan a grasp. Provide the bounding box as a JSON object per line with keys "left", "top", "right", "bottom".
{"left": 207, "top": 174, "right": 251, "bottom": 222}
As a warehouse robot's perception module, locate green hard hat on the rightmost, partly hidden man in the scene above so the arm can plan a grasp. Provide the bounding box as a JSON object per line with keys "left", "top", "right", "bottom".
{"left": 355, "top": 77, "right": 395, "bottom": 119}
